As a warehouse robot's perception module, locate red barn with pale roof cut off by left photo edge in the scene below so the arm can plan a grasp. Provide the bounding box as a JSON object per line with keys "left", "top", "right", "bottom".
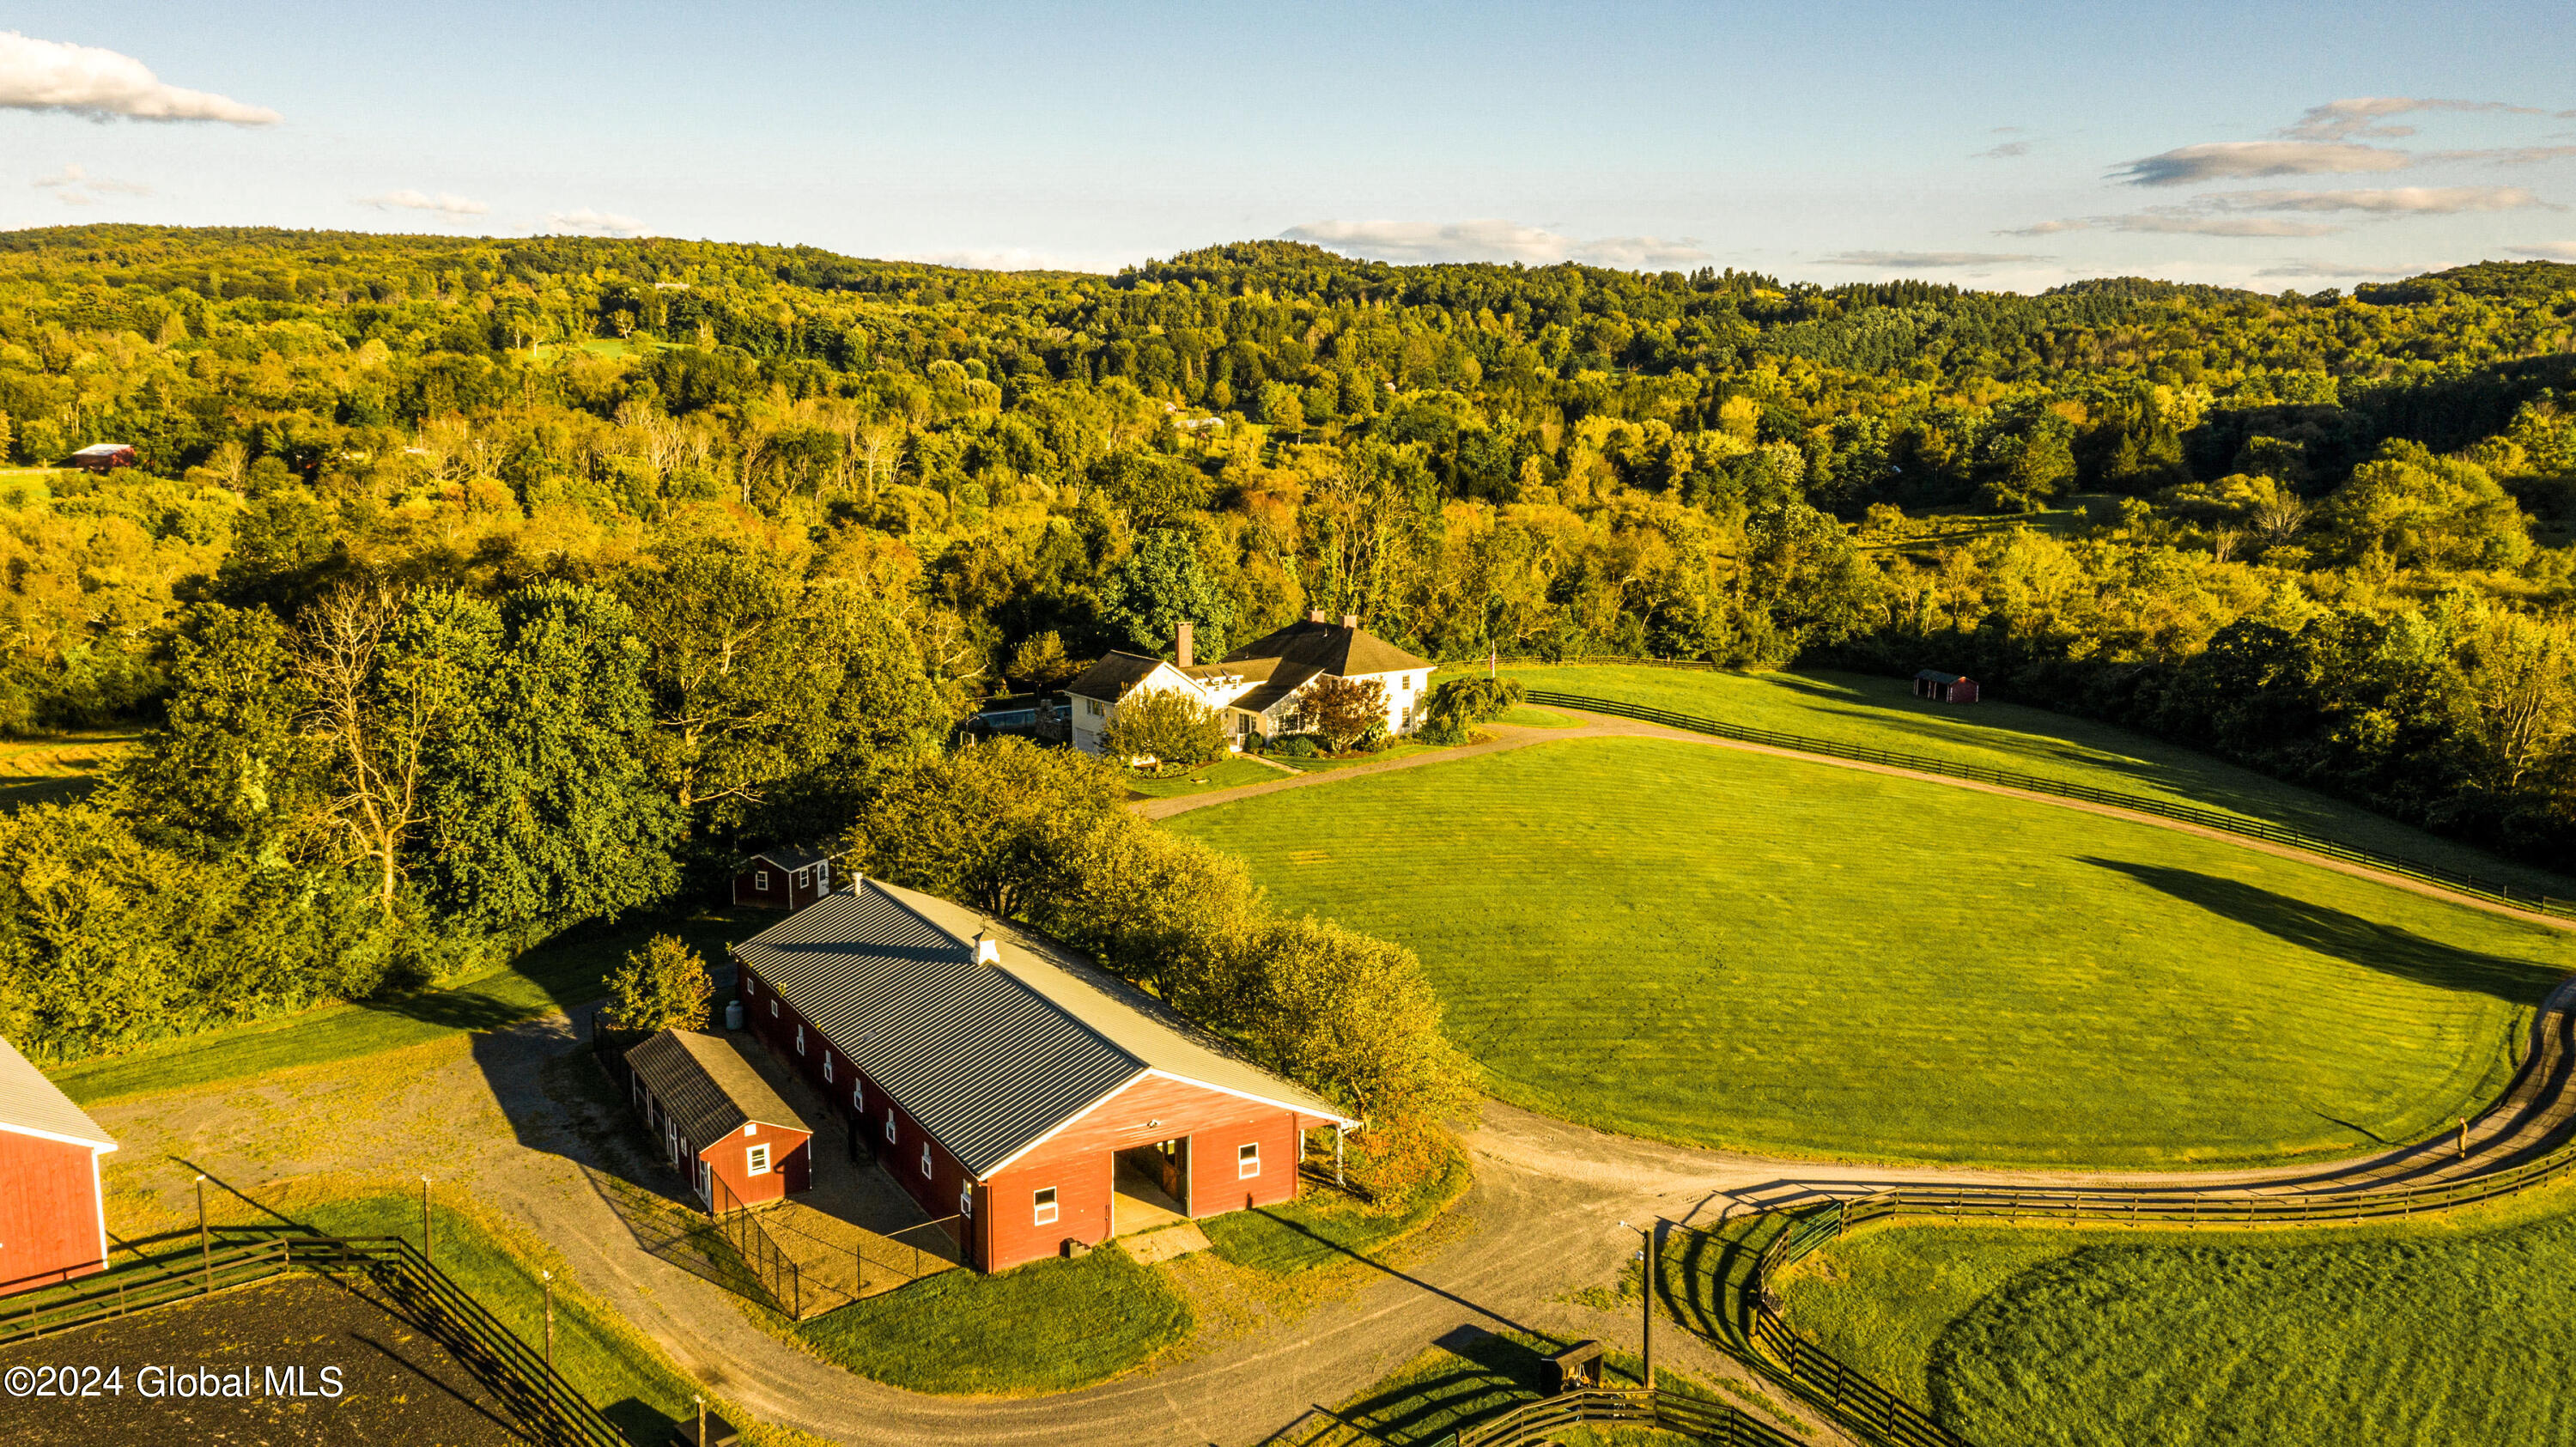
{"left": 0, "top": 1040, "right": 116, "bottom": 1295}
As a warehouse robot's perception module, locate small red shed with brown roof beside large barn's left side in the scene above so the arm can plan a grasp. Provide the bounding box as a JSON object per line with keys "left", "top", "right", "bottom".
{"left": 626, "top": 1030, "right": 814, "bottom": 1210}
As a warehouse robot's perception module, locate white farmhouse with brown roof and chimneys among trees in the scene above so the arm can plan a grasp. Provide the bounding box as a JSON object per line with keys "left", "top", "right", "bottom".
{"left": 1064, "top": 611, "right": 1432, "bottom": 754}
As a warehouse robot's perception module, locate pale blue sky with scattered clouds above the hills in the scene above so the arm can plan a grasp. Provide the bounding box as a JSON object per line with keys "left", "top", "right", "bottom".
{"left": 0, "top": 0, "right": 2576, "bottom": 291}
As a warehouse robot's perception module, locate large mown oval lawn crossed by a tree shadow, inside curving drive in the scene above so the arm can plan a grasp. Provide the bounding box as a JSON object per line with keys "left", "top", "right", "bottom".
{"left": 1170, "top": 739, "right": 2576, "bottom": 1169}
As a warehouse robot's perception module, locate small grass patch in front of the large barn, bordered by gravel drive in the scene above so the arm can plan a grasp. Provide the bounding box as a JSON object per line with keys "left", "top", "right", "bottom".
{"left": 796, "top": 1246, "right": 1193, "bottom": 1395}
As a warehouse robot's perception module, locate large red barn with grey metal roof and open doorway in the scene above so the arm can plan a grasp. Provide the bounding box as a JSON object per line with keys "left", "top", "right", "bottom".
{"left": 734, "top": 878, "right": 1358, "bottom": 1272}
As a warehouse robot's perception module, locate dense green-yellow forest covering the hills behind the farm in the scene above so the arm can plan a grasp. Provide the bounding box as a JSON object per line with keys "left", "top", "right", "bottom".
{"left": 0, "top": 227, "right": 2576, "bottom": 1081}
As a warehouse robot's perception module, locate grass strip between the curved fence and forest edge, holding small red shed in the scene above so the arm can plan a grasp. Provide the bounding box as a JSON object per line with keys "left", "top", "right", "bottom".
{"left": 1484, "top": 665, "right": 2576, "bottom": 896}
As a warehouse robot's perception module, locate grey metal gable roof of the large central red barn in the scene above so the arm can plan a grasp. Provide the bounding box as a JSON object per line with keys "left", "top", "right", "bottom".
{"left": 734, "top": 880, "right": 1358, "bottom": 1179}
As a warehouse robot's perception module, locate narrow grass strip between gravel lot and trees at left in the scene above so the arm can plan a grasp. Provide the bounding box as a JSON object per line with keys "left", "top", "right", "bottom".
{"left": 46, "top": 911, "right": 775, "bottom": 1104}
